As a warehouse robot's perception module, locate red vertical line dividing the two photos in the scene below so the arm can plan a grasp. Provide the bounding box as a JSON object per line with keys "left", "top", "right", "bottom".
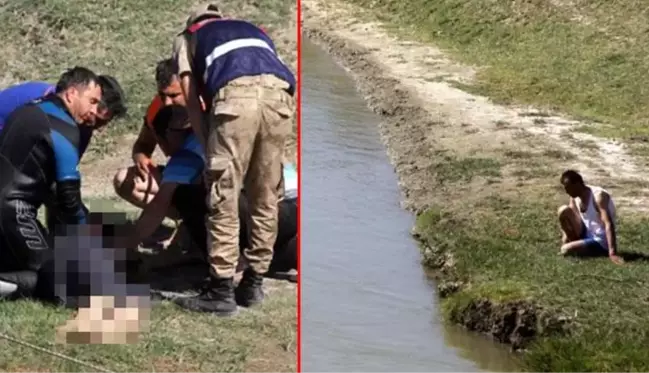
{"left": 296, "top": 0, "right": 303, "bottom": 373}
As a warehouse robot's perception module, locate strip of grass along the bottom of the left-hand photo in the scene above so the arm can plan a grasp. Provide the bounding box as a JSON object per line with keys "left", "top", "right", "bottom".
{"left": 0, "top": 296, "right": 297, "bottom": 372}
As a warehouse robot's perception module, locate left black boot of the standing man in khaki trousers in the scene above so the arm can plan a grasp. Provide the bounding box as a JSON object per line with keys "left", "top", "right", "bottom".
{"left": 174, "top": 277, "right": 237, "bottom": 316}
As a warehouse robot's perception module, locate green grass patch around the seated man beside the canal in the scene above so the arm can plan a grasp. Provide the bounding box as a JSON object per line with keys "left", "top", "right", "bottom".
{"left": 416, "top": 152, "right": 649, "bottom": 372}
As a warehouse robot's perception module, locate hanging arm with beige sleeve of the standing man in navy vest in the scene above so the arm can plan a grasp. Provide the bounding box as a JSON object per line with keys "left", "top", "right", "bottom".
{"left": 173, "top": 34, "right": 206, "bottom": 149}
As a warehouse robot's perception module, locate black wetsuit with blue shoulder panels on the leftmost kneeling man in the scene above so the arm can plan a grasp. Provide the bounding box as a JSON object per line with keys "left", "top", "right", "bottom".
{"left": 0, "top": 96, "right": 87, "bottom": 272}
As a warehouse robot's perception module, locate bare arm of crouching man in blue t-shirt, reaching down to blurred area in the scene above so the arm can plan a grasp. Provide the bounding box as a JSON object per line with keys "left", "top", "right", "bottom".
{"left": 127, "top": 183, "right": 177, "bottom": 249}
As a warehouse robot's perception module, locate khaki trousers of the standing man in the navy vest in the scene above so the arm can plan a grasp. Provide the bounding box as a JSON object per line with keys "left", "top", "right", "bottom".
{"left": 205, "top": 75, "right": 295, "bottom": 278}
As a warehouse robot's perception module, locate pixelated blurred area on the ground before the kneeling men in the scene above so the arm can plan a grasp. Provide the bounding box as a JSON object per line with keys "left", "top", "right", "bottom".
{"left": 54, "top": 212, "right": 151, "bottom": 344}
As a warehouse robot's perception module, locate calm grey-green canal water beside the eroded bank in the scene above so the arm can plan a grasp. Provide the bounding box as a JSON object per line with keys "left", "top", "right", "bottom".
{"left": 300, "top": 41, "right": 516, "bottom": 373}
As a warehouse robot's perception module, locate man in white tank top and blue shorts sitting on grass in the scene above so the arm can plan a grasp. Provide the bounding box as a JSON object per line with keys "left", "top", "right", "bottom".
{"left": 559, "top": 170, "right": 623, "bottom": 264}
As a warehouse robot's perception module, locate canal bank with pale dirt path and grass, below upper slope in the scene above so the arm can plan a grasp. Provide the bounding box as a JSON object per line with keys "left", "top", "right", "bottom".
{"left": 302, "top": 0, "right": 649, "bottom": 372}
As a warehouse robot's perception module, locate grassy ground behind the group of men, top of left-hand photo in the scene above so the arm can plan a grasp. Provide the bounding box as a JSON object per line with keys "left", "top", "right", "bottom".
{"left": 0, "top": 0, "right": 297, "bottom": 157}
